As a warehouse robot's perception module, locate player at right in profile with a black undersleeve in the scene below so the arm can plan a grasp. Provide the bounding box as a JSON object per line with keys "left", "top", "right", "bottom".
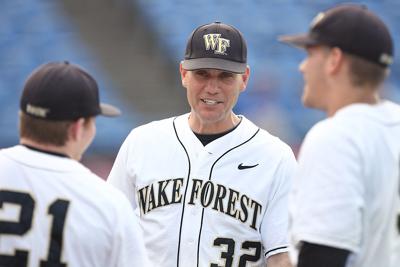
{"left": 281, "top": 4, "right": 400, "bottom": 267}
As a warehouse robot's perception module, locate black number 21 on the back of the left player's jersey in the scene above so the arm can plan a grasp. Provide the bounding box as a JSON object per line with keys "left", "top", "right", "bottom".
{"left": 0, "top": 190, "right": 69, "bottom": 267}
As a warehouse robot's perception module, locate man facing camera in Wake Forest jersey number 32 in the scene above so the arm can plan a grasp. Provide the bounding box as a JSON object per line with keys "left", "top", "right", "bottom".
{"left": 108, "top": 22, "right": 296, "bottom": 267}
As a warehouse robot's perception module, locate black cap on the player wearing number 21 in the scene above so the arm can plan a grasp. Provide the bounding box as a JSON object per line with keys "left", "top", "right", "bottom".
{"left": 20, "top": 61, "right": 121, "bottom": 120}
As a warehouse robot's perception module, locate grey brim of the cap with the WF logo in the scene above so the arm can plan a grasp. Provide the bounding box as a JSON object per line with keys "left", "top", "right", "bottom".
{"left": 182, "top": 58, "right": 247, "bottom": 73}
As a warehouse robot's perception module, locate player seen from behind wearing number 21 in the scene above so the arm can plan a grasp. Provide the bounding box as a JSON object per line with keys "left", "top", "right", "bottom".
{"left": 0, "top": 62, "right": 149, "bottom": 267}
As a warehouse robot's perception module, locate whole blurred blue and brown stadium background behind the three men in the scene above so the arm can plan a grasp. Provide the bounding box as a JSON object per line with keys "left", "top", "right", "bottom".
{"left": 0, "top": 0, "right": 400, "bottom": 180}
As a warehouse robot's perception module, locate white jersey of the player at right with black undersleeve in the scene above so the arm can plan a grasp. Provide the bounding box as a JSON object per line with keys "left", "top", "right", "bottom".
{"left": 289, "top": 101, "right": 400, "bottom": 267}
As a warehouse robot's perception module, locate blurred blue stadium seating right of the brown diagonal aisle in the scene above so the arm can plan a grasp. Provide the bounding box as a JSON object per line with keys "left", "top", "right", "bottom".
{"left": 132, "top": 0, "right": 400, "bottom": 147}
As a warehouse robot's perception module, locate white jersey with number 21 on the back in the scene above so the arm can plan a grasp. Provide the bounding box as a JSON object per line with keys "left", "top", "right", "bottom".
{"left": 0, "top": 145, "right": 148, "bottom": 267}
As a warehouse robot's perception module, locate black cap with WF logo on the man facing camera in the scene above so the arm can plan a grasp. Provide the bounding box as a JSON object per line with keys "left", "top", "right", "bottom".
{"left": 182, "top": 22, "right": 247, "bottom": 73}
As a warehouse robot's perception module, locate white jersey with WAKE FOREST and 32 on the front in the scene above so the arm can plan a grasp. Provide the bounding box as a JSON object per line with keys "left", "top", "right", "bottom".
{"left": 108, "top": 114, "right": 296, "bottom": 267}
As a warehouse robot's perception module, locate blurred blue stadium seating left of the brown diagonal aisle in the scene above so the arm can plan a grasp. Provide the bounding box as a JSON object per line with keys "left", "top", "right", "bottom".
{"left": 0, "top": 0, "right": 138, "bottom": 152}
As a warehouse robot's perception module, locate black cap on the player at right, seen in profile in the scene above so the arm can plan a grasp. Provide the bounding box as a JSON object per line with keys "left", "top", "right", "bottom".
{"left": 279, "top": 4, "right": 393, "bottom": 67}
